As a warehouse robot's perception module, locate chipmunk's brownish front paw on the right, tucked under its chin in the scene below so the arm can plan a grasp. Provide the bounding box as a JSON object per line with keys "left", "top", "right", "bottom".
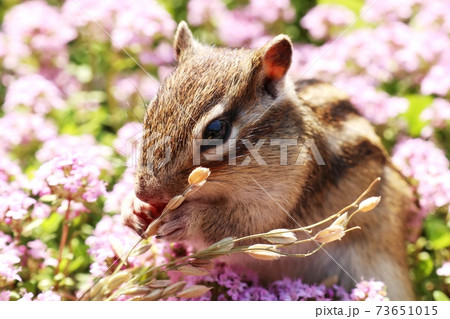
{"left": 156, "top": 207, "right": 191, "bottom": 242}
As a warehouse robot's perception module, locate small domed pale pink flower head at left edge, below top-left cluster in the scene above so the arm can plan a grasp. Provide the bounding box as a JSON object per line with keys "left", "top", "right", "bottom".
{"left": 3, "top": 74, "right": 64, "bottom": 114}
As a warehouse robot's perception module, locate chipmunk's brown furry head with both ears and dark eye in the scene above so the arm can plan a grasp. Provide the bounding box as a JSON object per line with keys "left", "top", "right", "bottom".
{"left": 136, "top": 22, "right": 302, "bottom": 218}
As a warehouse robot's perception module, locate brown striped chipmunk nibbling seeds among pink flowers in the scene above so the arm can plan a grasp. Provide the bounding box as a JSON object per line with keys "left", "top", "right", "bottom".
{"left": 122, "top": 22, "right": 414, "bottom": 300}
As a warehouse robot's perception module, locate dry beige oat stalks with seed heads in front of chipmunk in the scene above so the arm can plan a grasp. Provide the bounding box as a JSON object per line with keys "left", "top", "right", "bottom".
{"left": 84, "top": 168, "right": 381, "bottom": 300}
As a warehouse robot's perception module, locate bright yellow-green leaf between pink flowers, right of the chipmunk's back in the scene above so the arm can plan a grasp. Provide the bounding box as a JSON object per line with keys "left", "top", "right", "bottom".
{"left": 402, "top": 94, "right": 433, "bottom": 137}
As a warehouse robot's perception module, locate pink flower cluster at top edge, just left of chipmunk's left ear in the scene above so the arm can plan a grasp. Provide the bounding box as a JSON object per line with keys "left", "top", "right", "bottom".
{"left": 62, "top": 0, "right": 176, "bottom": 65}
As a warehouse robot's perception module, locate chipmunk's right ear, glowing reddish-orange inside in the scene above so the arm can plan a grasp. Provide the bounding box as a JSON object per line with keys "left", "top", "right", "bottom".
{"left": 259, "top": 34, "right": 292, "bottom": 81}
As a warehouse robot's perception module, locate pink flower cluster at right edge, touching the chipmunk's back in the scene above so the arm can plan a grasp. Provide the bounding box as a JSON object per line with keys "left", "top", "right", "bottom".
{"left": 392, "top": 139, "right": 450, "bottom": 215}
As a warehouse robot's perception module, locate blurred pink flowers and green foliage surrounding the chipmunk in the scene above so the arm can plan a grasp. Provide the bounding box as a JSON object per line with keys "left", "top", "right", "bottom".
{"left": 0, "top": 0, "right": 450, "bottom": 300}
